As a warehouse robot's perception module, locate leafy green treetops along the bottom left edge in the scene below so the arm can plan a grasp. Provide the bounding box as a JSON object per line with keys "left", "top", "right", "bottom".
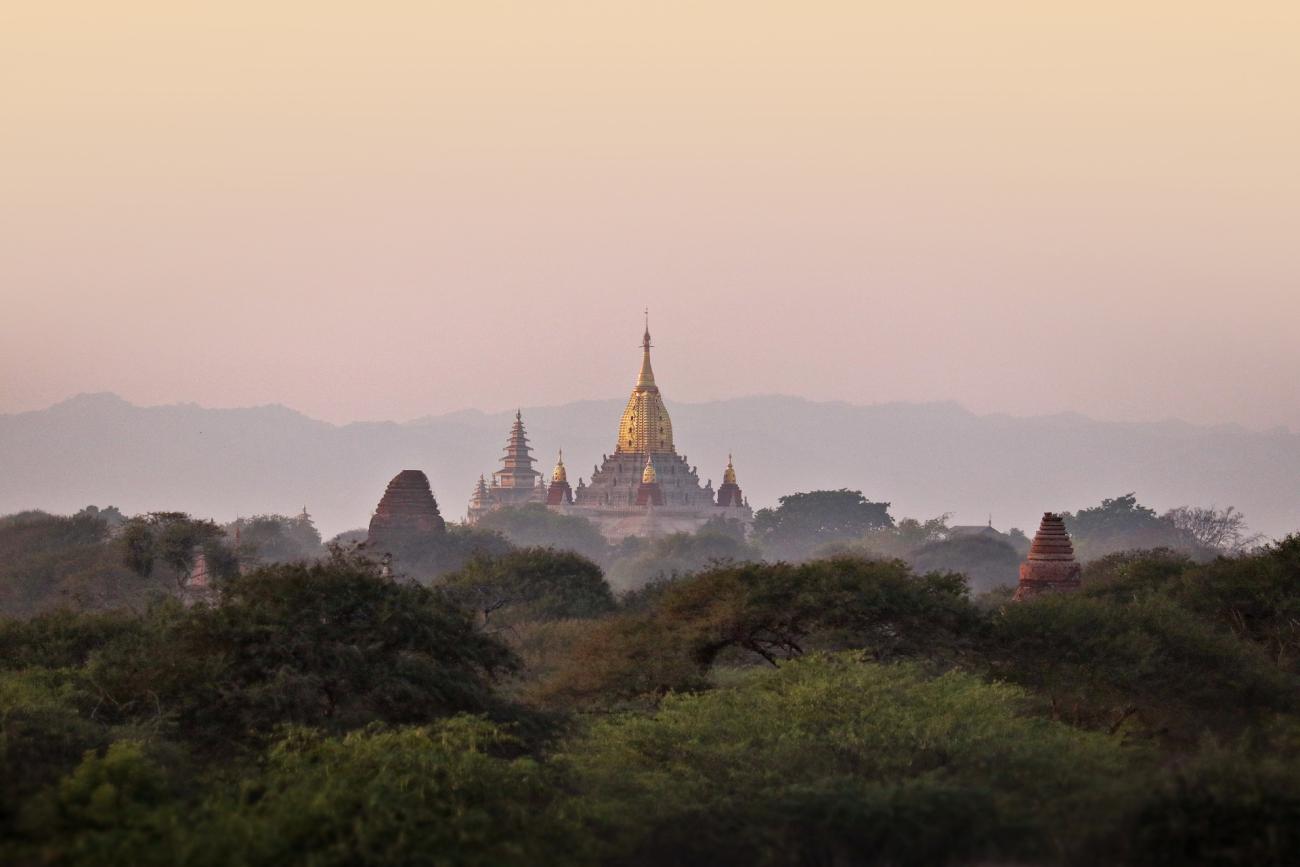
{"left": 21, "top": 716, "right": 590, "bottom": 867}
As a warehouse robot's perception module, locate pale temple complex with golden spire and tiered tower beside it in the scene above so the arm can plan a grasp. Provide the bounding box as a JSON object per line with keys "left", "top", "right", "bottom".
{"left": 468, "top": 326, "right": 754, "bottom": 542}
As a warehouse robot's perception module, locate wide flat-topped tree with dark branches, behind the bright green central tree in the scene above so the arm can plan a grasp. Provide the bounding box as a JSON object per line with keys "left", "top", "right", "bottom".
{"left": 538, "top": 558, "right": 982, "bottom": 705}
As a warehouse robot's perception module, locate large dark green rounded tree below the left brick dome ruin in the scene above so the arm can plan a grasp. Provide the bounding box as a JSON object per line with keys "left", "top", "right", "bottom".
{"left": 78, "top": 558, "right": 516, "bottom": 747}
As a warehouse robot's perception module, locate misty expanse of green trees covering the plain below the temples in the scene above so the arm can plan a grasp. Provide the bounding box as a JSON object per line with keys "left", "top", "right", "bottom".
{"left": 0, "top": 491, "right": 1300, "bottom": 867}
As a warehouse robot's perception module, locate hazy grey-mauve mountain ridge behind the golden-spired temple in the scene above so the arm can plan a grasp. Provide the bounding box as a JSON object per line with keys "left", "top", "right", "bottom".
{"left": 0, "top": 394, "right": 1300, "bottom": 536}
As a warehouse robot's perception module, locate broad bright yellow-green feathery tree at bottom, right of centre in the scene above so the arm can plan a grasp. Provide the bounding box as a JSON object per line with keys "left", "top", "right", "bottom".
{"left": 560, "top": 654, "right": 1135, "bottom": 864}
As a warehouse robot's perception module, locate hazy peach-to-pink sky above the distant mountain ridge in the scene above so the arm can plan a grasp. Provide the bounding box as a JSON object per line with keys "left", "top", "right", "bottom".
{"left": 0, "top": 0, "right": 1300, "bottom": 429}
